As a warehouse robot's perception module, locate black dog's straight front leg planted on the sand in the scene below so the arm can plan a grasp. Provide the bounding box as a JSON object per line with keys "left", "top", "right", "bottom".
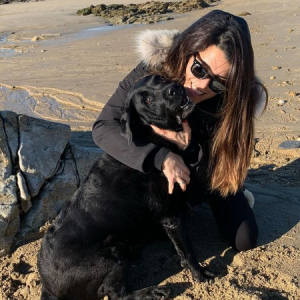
{"left": 161, "top": 216, "right": 208, "bottom": 282}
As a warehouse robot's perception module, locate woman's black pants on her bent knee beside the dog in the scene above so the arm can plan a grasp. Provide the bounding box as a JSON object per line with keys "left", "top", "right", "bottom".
{"left": 187, "top": 182, "right": 258, "bottom": 251}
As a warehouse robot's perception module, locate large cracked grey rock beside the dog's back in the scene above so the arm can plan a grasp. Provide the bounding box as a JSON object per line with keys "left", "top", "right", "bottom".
{"left": 0, "top": 111, "right": 102, "bottom": 256}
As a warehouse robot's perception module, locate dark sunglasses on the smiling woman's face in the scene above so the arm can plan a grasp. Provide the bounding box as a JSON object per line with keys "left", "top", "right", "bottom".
{"left": 191, "top": 53, "right": 226, "bottom": 94}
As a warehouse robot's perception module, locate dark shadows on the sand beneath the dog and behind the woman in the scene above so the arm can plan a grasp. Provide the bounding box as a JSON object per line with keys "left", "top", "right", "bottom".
{"left": 129, "top": 159, "right": 300, "bottom": 300}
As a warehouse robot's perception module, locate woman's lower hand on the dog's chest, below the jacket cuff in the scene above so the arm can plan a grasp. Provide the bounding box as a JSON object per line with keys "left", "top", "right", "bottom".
{"left": 162, "top": 152, "right": 190, "bottom": 194}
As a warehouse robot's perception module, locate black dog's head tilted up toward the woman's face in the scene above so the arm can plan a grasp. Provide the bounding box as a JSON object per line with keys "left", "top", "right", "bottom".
{"left": 121, "top": 75, "right": 194, "bottom": 144}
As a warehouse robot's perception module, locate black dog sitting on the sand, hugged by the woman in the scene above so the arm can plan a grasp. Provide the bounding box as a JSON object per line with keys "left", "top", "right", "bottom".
{"left": 38, "top": 76, "right": 205, "bottom": 300}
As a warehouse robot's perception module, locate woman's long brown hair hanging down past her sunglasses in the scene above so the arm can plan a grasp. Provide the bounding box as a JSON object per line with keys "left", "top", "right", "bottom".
{"left": 153, "top": 10, "right": 266, "bottom": 196}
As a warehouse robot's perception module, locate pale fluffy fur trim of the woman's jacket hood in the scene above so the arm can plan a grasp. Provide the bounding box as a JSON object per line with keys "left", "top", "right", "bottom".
{"left": 136, "top": 30, "right": 267, "bottom": 119}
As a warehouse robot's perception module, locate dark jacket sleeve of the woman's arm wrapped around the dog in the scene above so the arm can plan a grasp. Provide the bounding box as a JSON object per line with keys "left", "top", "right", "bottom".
{"left": 92, "top": 63, "right": 169, "bottom": 173}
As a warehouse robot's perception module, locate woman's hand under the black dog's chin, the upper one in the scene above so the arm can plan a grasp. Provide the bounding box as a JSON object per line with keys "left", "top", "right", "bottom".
{"left": 150, "top": 120, "right": 192, "bottom": 150}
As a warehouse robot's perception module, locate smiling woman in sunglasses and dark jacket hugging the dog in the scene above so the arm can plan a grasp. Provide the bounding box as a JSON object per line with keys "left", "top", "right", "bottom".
{"left": 93, "top": 10, "right": 267, "bottom": 251}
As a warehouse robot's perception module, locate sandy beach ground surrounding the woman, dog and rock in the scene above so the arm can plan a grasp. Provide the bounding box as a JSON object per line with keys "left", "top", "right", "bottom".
{"left": 0, "top": 0, "right": 300, "bottom": 300}
